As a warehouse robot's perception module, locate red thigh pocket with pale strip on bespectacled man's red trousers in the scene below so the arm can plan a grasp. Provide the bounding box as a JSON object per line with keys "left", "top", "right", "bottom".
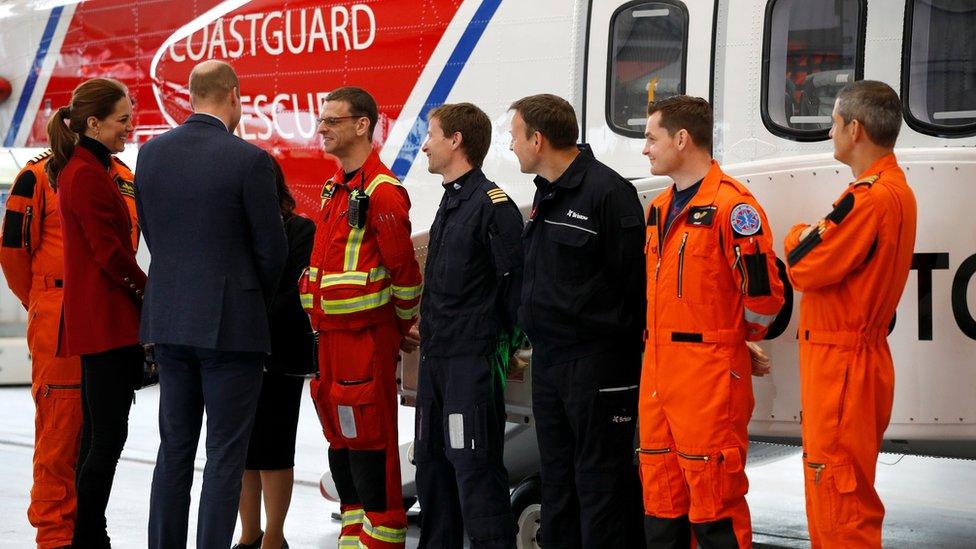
{"left": 331, "top": 379, "right": 383, "bottom": 450}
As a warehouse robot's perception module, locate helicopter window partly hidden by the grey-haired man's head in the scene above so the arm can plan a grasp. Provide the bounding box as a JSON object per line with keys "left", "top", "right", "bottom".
{"left": 762, "top": 0, "right": 865, "bottom": 141}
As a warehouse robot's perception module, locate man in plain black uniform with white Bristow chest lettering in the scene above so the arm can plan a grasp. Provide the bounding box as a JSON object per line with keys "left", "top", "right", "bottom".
{"left": 511, "top": 95, "right": 645, "bottom": 549}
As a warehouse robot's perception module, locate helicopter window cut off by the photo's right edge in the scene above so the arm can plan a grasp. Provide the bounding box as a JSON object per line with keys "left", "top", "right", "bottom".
{"left": 902, "top": 0, "right": 976, "bottom": 137}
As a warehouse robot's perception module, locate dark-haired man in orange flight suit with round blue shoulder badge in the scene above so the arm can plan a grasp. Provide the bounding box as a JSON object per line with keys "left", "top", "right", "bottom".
{"left": 637, "top": 96, "right": 783, "bottom": 549}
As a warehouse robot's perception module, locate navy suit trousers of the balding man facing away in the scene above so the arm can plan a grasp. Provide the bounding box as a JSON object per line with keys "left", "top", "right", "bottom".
{"left": 149, "top": 344, "right": 266, "bottom": 549}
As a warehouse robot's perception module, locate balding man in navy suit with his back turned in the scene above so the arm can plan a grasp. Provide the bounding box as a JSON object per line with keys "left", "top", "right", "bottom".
{"left": 135, "top": 61, "right": 288, "bottom": 549}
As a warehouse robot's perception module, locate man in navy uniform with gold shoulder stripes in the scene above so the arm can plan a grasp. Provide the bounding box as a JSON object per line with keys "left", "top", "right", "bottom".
{"left": 414, "top": 103, "right": 522, "bottom": 549}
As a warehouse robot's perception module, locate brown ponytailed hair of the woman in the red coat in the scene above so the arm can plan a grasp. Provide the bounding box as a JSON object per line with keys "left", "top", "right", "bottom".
{"left": 45, "top": 78, "right": 129, "bottom": 186}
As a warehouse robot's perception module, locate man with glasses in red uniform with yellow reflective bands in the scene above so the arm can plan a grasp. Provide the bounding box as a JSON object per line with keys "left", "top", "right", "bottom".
{"left": 301, "top": 87, "right": 421, "bottom": 549}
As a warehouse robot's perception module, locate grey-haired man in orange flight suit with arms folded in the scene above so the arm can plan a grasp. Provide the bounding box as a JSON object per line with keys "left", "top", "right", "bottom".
{"left": 785, "top": 81, "right": 916, "bottom": 548}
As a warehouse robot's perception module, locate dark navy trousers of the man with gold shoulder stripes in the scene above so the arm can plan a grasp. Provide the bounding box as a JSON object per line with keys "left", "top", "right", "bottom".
{"left": 414, "top": 356, "right": 515, "bottom": 549}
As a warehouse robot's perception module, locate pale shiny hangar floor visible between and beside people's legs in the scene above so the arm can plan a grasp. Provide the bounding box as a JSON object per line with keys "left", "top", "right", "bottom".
{"left": 0, "top": 388, "right": 976, "bottom": 549}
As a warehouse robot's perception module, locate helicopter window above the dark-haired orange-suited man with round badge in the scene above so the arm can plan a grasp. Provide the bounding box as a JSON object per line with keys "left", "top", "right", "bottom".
{"left": 607, "top": 1, "right": 688, "bottom": 137}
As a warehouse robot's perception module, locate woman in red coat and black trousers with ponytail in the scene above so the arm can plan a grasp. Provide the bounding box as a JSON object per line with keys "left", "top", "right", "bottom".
{"left": 47, "top": 78, "right": 146, "bottom": 549}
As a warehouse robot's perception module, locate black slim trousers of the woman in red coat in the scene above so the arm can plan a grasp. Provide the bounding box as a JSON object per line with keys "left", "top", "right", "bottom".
{"left": 72, "top": 345, "right": 144, "bottom": 549}
